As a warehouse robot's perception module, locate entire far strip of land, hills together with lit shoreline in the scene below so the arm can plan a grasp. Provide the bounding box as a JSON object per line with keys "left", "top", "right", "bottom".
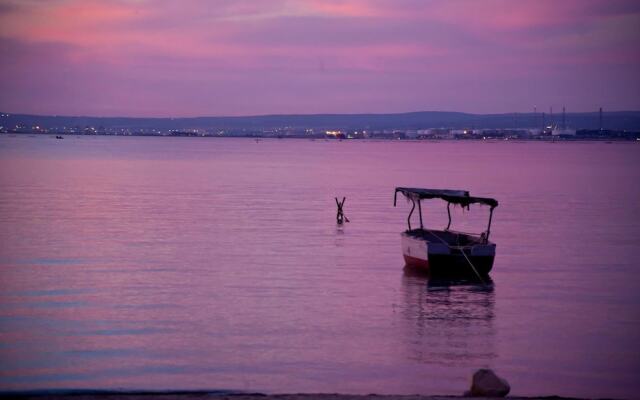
{"left": 0, "top": 110, "right": 640, "bottom": 135}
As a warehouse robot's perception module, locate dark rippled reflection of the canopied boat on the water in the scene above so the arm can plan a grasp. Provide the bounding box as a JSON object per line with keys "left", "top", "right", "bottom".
{"left": 401, "top": 268, "right": 497, "bottom": 368}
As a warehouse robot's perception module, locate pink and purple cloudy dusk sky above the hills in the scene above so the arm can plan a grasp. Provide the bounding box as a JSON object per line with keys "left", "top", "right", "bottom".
{"left": 0, "top": 0, "right": 640, "bottom": 116}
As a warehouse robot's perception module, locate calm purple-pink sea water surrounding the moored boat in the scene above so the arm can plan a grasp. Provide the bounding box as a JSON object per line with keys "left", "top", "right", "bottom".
{"left": 0, "top": 136, "right": 640, "bottom": 398}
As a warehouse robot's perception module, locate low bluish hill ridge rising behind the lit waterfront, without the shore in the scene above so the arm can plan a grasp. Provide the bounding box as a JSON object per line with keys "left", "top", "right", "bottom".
{"left": 0, "top": 111, "right": 640, "bottom": 131}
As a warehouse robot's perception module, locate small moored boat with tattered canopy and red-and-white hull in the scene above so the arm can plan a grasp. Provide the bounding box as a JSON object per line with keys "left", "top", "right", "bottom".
{"left": 393, "top": 187, "right": 498, "bottom": 277}
